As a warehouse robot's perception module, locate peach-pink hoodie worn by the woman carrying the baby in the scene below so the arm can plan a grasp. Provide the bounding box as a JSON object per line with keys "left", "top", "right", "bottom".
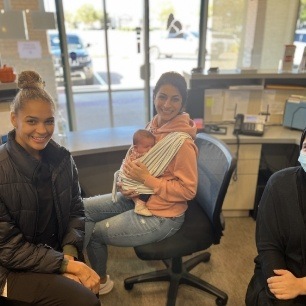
{"left": 144, "top": 113, "right": 198, "bottom": 217}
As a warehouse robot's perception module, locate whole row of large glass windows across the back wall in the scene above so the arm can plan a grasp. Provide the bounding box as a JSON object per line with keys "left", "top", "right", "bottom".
{"left": 41, "top": 0, "right": 303, "bottom": 130}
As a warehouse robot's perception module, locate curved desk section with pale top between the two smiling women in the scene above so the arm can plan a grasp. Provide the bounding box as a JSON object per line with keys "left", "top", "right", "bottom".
{"left": 53, "top": 126, "right": 143, "bottom": 196}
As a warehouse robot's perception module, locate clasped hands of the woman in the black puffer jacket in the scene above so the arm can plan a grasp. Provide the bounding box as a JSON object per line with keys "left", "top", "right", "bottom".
{"left": 65, "top": 260, "right": 100, "bottom": 294}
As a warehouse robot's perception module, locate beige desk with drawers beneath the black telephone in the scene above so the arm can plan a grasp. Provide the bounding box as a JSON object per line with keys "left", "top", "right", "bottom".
{"left": 207, "top": 126, "right": 301, "bottom": 217}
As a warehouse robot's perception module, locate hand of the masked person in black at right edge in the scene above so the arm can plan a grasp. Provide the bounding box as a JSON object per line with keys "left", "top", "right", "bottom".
{"left": 267, "top": 269, "right": 306, "bottom": 300}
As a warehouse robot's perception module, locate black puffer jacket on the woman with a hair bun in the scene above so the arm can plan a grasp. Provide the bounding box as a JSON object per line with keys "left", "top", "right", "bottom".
{"left": 0, "top": 130, "right": 85, "bottom": 294}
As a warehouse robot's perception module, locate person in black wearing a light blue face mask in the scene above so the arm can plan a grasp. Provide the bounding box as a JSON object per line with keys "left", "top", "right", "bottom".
{"left": 245, "top": 129, "right": 306, "bottom": 306}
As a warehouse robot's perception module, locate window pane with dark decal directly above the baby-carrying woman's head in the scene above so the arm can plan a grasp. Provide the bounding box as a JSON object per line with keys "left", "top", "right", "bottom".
{"left": 150, "top": 0, "right": 200, "bottom": 84}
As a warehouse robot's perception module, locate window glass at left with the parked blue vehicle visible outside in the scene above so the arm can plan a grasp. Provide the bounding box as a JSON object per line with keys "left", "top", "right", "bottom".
{"left": 46, "top": 0, "right": 148, "bottom": 130}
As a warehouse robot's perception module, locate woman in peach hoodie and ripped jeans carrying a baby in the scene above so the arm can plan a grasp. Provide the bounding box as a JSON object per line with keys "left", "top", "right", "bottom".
{"left": 84, "top": 72, "right": 198, "bottom": 295}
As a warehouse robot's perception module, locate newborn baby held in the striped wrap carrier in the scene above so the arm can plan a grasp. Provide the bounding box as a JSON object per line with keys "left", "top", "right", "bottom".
{"left": 119, "top": 129, "right": 155, "bottom": 216}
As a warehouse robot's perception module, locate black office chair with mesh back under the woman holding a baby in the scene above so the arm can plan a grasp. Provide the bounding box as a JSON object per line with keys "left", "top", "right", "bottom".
{"left": 124, "top": 133, "right": 236, "bottom": 306}
